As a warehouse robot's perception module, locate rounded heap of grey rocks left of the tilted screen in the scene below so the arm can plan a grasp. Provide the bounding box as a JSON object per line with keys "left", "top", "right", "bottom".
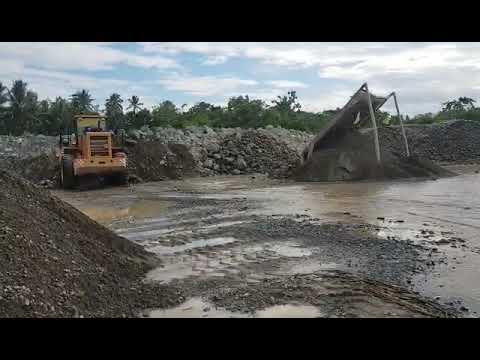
{"left": 203, "top": 130, "right": 300, "bottom": 178}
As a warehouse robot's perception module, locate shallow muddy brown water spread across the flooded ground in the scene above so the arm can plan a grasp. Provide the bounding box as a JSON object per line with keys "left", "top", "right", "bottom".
{"left": 57, "top": 172, "right": 480, "bottom": 312}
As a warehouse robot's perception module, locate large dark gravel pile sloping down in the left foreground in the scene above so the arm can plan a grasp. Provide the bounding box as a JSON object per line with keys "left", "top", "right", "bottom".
{"left": 0, "top": 170, "right": 181, "bottom": 317}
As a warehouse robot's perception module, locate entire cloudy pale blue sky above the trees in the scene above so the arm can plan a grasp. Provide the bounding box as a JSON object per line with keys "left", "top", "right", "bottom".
{"left": 0, "top": 42, "right": 480, "bottom": 115}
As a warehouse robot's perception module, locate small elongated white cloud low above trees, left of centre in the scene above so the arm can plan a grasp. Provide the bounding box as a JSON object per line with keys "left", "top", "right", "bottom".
{"left": 158, "top": 75, "right": 258, "bottom": 96}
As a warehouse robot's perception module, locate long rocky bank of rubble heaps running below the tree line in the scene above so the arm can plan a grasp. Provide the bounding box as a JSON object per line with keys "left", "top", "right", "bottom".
{"left": 0, "top": 120, "right": 480, "bottom": 187}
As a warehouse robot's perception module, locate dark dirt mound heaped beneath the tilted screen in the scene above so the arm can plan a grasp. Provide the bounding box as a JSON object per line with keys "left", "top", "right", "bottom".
{"left": 294, "top": 132, "right": 454, "bottom": 181}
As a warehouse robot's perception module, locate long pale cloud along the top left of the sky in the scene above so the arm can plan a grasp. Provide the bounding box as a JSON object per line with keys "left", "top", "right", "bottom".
{"left": 0, "top": 42, "right": 179, "bottom": 71}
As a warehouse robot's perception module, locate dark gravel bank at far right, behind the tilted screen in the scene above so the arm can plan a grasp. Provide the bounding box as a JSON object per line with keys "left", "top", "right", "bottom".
{"left": 379, "top": 120, "right": 480, "bottom": 162}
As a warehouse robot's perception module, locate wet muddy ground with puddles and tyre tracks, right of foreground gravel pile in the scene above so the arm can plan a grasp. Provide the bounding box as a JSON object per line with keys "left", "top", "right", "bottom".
{"left": 54, "top": 165, "right": 480, "bottom": 317}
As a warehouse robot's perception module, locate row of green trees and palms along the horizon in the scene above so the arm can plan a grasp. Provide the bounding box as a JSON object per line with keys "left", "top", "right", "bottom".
{"left": 0, "top": 80, "right": 480, "bottom": 135}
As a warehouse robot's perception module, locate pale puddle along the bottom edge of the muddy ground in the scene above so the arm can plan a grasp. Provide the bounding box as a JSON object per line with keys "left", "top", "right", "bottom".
{"left": 147, "top": 297, "right": 323, "bottom": 318}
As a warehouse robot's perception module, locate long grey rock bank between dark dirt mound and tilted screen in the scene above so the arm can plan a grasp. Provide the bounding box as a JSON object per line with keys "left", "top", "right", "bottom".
{"left": 129, "top": 126, "right": 313, "bottom": 177}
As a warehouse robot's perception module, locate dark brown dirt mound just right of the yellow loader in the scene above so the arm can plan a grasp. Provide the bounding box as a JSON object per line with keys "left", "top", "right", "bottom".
{"left": 127, "top": 140, "right": 195, "bottom": 181}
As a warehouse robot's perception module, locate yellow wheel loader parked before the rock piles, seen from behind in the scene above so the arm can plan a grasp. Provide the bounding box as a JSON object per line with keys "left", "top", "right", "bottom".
{"left": 58, "top": 115, "right": 128, "bottom": 189}
